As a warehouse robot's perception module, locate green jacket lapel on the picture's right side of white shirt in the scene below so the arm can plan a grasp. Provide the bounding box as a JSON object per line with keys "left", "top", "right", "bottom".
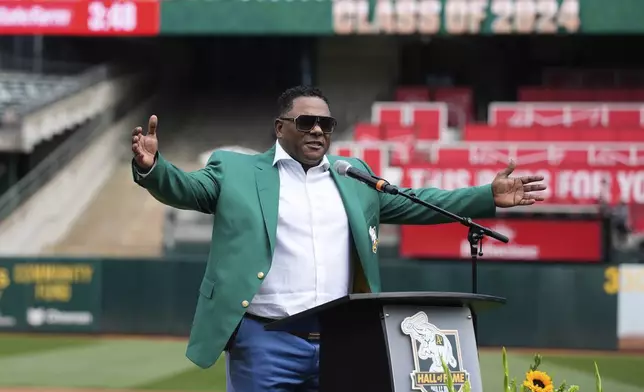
{"left": 329, "top": 156, "right": 370, "bottom": 266}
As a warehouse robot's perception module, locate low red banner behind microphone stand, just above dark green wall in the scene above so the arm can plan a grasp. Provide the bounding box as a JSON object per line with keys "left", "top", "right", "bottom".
{"left": 400, "top": 219, "right": 602, "bottom": 262}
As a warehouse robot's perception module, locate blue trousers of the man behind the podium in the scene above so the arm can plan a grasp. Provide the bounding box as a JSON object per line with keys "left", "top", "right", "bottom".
{"left": 226, "top": 317, "right": 320, "bottom": 392}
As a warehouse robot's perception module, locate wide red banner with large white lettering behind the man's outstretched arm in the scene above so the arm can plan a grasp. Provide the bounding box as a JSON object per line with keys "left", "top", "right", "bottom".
{"left": 334, "top": 142, "right": 644, "bottom": 205}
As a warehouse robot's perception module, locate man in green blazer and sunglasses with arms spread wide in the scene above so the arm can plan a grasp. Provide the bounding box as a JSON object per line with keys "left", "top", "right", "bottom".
{"left": 132, "top": 86, "right": 546, "bottom": 392}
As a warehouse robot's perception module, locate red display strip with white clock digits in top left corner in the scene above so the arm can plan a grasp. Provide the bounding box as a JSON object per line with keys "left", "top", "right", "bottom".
{"left": 0, "top": 0, "right": 160, "bottom": 36}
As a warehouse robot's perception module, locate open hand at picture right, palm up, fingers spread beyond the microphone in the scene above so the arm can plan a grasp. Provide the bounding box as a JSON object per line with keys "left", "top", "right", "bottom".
{"left": 492, "top": 161, "right": 546, "bottom": 208}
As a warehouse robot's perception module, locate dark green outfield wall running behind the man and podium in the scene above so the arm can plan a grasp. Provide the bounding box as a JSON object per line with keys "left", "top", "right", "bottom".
{"left": 0, "top": 258, "right": 644, "bottom": 349}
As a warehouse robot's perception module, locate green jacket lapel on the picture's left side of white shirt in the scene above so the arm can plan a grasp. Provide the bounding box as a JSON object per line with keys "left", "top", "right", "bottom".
{"left": 255, "top": 146, "right": 280, "bottom": 257}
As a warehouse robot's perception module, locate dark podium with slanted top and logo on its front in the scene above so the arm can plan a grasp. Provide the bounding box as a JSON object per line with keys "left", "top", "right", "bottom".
{"left": 265, "top": 292, "right": 505, "bottom": 392}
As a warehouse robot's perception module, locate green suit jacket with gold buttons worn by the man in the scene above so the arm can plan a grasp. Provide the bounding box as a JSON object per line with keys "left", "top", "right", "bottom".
{"left": 132, "top": 147, "right": 496, "bottom": 368}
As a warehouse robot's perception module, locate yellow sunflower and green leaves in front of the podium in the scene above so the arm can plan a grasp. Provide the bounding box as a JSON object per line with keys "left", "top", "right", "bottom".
{"left": 441, "top": 347, "right": 602, "bottom": 392}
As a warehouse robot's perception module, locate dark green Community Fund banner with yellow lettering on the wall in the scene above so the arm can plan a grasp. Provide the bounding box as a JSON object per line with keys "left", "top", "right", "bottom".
{"left": 0, "top": 259, "right": 101, "bottom": 332}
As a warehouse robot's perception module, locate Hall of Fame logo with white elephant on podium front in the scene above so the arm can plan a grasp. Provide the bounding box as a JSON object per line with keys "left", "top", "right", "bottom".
{"left": 400, "top": 312, "right": 470, "bottom": 392}
